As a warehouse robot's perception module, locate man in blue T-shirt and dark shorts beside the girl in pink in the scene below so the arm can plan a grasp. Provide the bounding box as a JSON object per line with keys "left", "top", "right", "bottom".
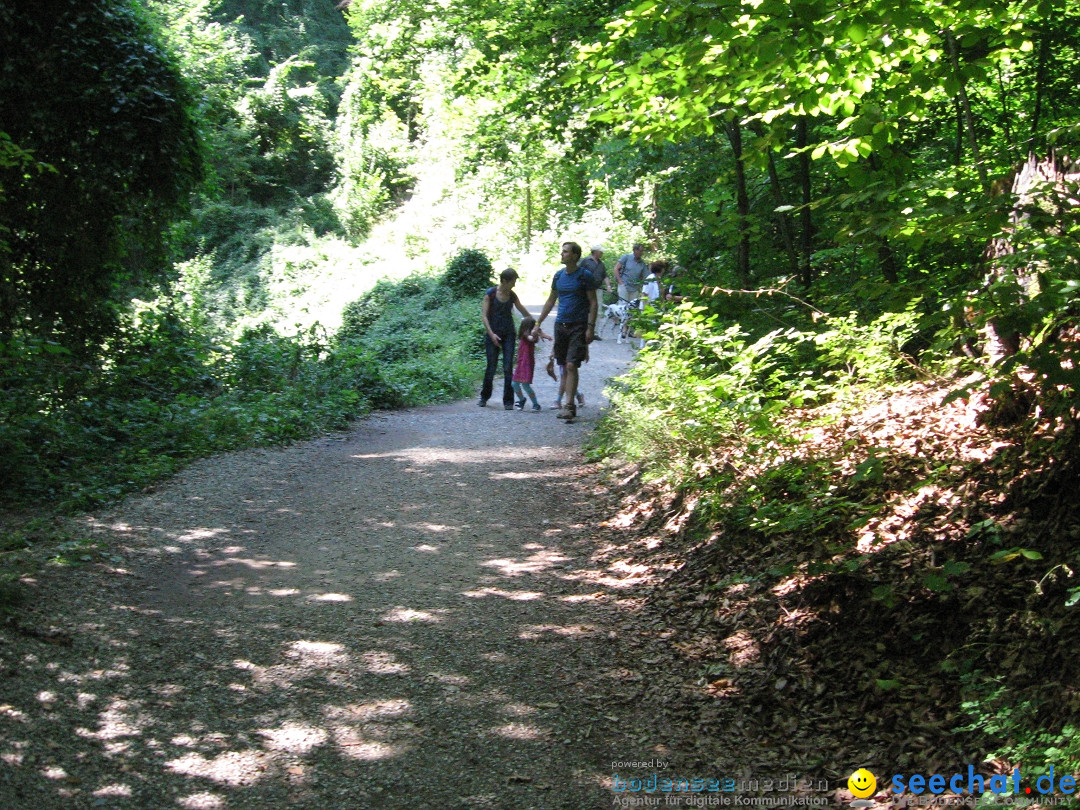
{"left": 532, "top": 242, "right": 596, "bottom": 420}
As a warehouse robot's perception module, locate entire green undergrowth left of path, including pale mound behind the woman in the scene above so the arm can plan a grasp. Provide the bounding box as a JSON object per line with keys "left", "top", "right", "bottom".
{"left": 0, "top": 253, "right": 483, "bottom": 512}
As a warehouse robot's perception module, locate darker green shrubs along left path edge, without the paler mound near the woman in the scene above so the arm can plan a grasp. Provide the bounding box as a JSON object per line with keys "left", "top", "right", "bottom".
{"left": 0, "top": 307, "right": 367, "bottom": 509}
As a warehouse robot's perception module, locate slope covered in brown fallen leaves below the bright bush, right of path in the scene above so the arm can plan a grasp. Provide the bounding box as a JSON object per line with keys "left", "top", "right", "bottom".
{"left": 602, "top": 384, "right": 1080, "bottom": 800}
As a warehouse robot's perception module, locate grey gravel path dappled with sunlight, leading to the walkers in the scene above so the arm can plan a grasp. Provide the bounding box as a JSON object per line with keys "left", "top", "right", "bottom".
{"left": 0, "top": 330, "right": 695, "bottom": 810}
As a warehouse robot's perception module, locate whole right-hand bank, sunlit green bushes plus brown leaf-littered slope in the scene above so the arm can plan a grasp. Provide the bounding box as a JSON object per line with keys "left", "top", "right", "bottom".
{"left": 590, "top": 295, "right": 1080, "bottom": 790}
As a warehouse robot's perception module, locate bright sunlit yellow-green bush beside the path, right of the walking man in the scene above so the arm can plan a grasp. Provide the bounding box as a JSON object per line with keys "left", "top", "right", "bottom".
{"left": 594, "top": 302, "right": 919, "bottom": 478}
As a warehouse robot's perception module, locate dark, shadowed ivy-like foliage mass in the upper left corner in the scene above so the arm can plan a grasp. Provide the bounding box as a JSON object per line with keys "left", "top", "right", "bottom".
{"left": 0, "top": 0, "right": 200, "bottom": 350}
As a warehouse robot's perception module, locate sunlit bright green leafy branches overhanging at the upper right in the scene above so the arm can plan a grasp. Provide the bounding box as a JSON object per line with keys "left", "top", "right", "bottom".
{"left": 570, "top": 0, "right": 1080, "bottom": 281}
